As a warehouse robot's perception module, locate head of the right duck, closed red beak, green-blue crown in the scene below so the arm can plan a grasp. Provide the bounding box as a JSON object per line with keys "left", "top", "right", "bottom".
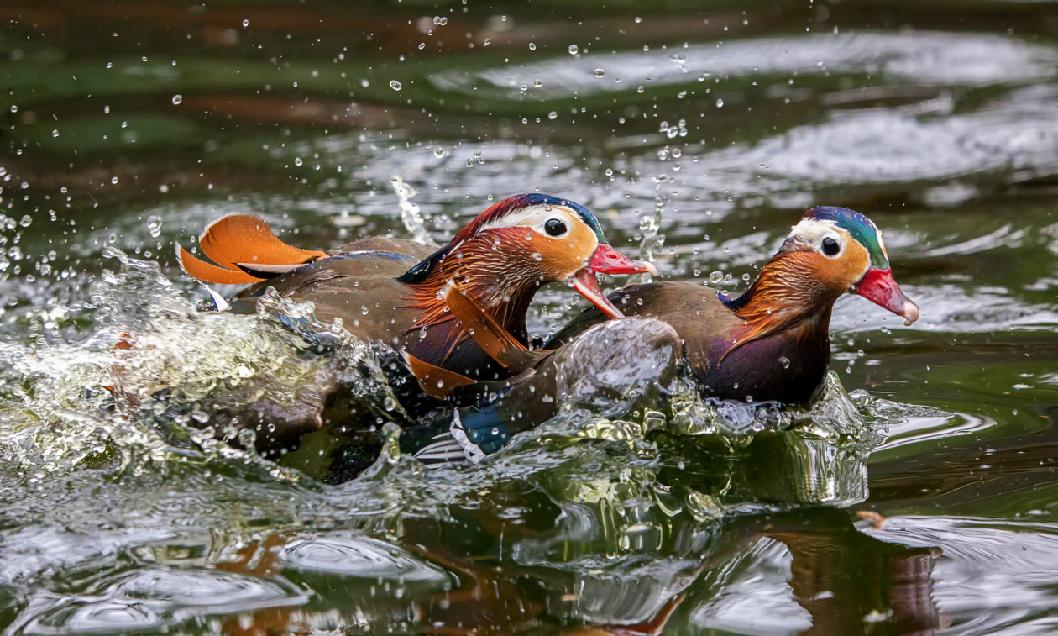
{"left": 780, "top": 206, "right": 918, "bottom": 325}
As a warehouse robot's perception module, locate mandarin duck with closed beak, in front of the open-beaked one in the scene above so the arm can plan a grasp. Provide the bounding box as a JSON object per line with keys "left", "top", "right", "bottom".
{"left": 417, "top": 206, "right": 918, "bottom": 461}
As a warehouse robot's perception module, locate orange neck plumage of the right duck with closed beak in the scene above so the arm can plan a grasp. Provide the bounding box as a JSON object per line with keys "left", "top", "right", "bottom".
{"left": 728, "top": 252, "right": 843, "bottom": 349}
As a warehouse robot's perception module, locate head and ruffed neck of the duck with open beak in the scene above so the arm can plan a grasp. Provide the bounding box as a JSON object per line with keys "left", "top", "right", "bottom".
{"left": 398, "top": 193, "right": 656, "bottom": 334}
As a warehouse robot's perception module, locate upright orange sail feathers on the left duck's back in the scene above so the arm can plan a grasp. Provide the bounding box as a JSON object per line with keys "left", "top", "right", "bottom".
{"left": 177, "top": 214, "right": 327, "bottom": 285}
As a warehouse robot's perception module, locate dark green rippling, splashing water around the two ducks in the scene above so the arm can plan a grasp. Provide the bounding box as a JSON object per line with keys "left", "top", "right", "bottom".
{"left": 0, "top": 0, "right": 1058, "bottom": 634}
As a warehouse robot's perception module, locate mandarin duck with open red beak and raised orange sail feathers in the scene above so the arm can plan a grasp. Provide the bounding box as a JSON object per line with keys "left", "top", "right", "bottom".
{"left": 177, "top": 193, "right": 654, "bottom": 406}
